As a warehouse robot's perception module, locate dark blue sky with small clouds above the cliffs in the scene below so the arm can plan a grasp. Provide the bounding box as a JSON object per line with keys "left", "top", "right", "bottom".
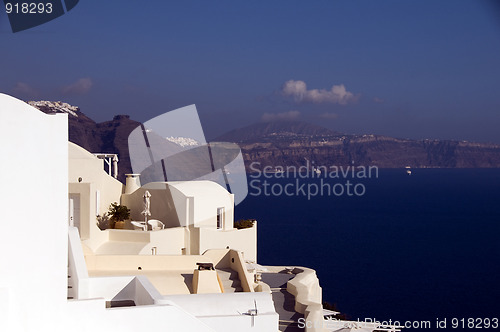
{"left": 0, "top": 0, "right": 500, "bottom": 143}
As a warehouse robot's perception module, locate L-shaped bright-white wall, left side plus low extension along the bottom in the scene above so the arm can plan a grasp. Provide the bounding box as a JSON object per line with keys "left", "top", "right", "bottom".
{"left": 0, "top": 94, "right": 223, "bottom": 332}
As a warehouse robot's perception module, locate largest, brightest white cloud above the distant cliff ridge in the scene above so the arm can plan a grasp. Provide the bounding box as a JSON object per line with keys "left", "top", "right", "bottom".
{"left": 281, "top": 80, "right": 359, "bottom": 105}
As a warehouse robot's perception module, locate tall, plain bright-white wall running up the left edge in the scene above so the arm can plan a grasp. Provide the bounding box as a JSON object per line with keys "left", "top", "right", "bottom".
{"left": 0, "top": 94, "right": 68, "bottom": 331}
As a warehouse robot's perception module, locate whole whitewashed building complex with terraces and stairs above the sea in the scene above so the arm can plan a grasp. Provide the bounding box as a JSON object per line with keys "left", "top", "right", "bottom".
{"left": 0, "top": 94, "right": 386, "bottom": 332}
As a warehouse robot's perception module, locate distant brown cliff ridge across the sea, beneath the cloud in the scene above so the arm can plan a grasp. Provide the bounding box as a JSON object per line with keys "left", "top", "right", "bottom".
{"left": 217, "top": 123, "right": 500, "bottom": 170}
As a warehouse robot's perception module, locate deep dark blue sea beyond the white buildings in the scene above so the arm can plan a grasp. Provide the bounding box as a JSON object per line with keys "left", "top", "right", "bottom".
{"left": 235, "top": 169, "right": 500, "bottom": 331}
